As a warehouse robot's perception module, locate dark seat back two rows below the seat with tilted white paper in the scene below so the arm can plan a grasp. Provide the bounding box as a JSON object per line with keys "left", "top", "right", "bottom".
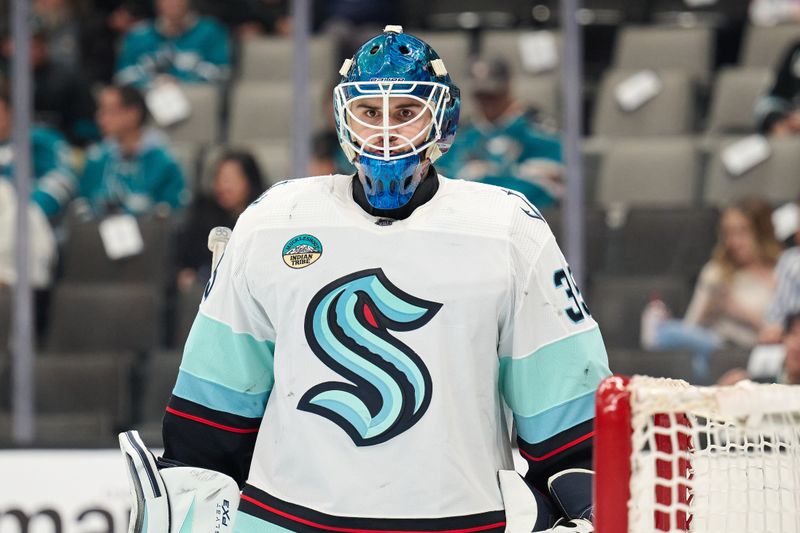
{"left": 613, "top": 207, "right": 719, "bottom": 279}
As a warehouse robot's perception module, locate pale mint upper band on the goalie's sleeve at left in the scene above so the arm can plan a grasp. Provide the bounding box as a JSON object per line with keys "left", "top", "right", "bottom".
{"left": 181, "top": 313, "right": 275, "bottom": 394}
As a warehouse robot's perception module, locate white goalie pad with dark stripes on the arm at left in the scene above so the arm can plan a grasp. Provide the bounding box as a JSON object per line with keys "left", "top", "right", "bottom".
{"left": 119, "top": 431, "right": 239, "bottom": 533}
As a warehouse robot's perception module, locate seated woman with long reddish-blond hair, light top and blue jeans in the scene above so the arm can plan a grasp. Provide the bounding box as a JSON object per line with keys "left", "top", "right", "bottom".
{"left": 642, "top": 198, "right": 780, "bottom": 384}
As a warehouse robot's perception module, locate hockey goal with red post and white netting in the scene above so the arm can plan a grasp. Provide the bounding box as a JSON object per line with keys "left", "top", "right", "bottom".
{"left": 594, "top": 376, "right": 800, "bottom": 533}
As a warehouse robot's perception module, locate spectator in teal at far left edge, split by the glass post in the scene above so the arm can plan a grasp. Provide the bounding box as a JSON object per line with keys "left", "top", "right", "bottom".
{"left": 0, "top": 87, "right": 77, "bottom": 223}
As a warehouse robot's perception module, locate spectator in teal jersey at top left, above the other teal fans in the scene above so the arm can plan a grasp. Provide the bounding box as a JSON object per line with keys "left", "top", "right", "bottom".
{"left": 114, "top": 0, "right": 230, "bottom": 87}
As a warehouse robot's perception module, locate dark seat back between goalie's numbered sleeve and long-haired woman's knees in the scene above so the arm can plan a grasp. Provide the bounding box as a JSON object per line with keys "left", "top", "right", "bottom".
{"left": 586, "top": 275, "right": 689, "bottom": 350}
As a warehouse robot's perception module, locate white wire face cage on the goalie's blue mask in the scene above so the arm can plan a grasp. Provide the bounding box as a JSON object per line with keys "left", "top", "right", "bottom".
{"left": 334, "top": 81, "right": 450, "bottom": 161}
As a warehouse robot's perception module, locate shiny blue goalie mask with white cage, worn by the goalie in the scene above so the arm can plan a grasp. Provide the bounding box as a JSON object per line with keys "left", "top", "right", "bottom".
{"left": 333, "top": 26, "right": 461, "bottom": 209}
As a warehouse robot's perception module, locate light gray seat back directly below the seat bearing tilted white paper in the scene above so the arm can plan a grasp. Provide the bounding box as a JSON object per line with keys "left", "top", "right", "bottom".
{"left": 597, "top": 137, "right": 699, "bottom": 207}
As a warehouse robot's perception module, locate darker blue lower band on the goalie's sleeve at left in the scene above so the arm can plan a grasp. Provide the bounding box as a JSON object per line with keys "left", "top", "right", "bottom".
{"left": 173, "top": 370, "right": 270, "bottom": 418}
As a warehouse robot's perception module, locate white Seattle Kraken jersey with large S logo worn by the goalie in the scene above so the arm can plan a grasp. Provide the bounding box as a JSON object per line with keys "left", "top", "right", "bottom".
{"left": 168, "top": 175, "right": 609, "bottom": 532}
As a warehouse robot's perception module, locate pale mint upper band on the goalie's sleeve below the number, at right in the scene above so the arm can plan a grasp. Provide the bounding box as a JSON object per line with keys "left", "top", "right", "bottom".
{"left": 500, "top": 326, "right": 610, "bottom": 417}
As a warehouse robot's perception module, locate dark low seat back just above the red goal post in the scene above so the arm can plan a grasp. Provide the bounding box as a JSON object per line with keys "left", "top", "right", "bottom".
{"left": 608, "top": 348, "right": 692, "bottom": 381}
